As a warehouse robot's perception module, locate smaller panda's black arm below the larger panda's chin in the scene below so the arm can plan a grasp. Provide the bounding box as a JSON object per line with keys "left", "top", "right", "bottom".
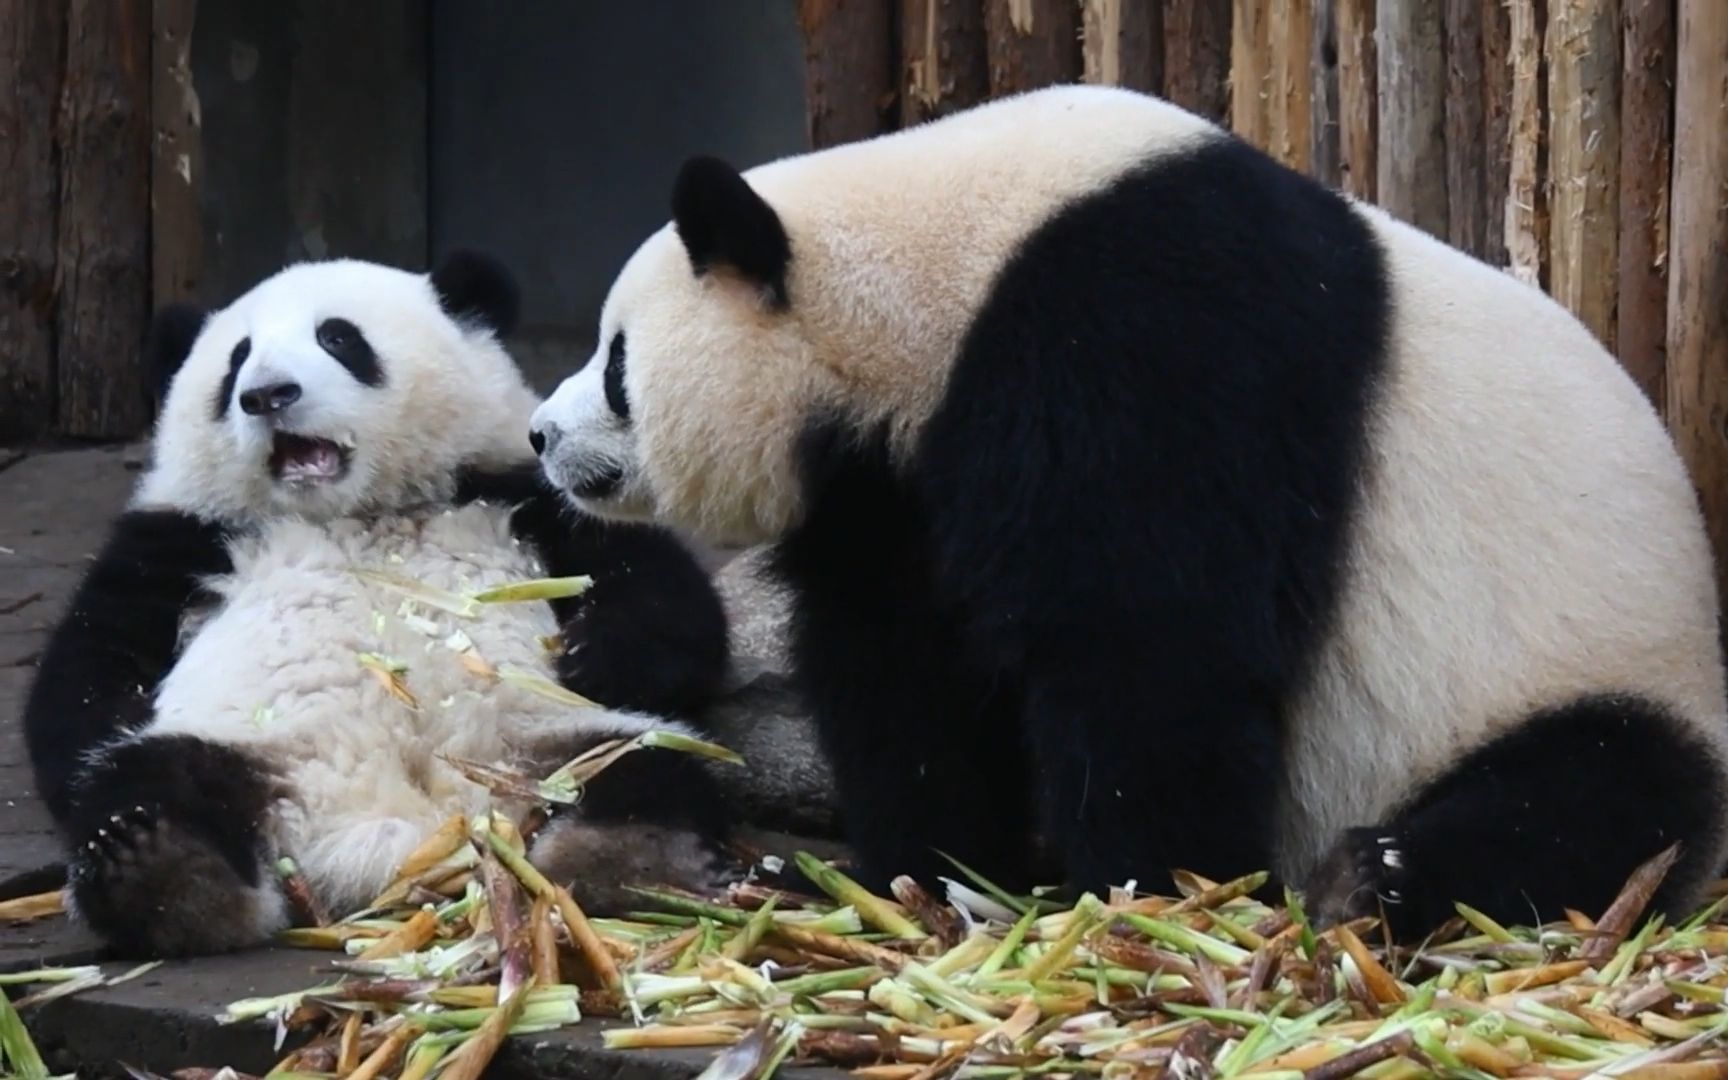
{"left": 456, "top": 467, "right": 727, "bottom": 719}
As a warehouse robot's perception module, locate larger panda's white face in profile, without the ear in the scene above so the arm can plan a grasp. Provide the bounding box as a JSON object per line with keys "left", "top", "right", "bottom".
{"left": 530, "top": 228, "right": 817, "bottom": 546}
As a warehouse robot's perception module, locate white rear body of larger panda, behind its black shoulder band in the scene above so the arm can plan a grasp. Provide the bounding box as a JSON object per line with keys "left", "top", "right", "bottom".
{"left": 1280, "top": 206, "right": 1728, "bottom": 873}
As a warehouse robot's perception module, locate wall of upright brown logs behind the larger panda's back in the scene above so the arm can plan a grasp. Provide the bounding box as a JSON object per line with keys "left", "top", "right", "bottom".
{"left": 791, "top": 0, "right": 1728, "bottom": 597}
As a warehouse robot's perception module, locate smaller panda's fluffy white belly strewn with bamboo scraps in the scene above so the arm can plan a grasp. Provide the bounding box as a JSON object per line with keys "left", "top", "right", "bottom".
{"left": 139, "top": 506, "right": 580, "bottom": 902}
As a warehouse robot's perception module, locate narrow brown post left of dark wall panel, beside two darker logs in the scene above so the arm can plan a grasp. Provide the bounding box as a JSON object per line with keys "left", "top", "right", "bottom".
{"left": 150, "top": 0, "right": 204, "bottom": 306}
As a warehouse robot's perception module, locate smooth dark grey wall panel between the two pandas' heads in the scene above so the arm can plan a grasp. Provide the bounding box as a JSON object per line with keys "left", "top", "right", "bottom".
{"left": 430, "top": 0, "right": 805, "bottom": 385}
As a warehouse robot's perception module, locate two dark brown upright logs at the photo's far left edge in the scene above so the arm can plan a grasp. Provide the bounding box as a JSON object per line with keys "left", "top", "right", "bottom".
{"left": 0, "top": 0, "right": 150, "bottom": 444}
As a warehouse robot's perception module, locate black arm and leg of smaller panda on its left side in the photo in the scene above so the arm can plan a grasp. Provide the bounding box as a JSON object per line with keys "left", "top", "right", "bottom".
{"left": 24, "top": 511, "right": 270, "bottom": 956}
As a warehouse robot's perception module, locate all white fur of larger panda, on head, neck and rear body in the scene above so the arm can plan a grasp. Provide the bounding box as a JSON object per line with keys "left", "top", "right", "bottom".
{"left": 534, "top": 86, "right": 1728, "bottom": 876}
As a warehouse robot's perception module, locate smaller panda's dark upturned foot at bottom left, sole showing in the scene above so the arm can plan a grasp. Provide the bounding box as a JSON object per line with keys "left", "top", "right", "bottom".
{"left": 66, "top": 804, "right": 287, "bottom": 957}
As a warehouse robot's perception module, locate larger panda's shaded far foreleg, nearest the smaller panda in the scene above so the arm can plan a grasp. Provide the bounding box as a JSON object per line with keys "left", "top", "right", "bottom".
{"left": 772, "top": 429, "right": 1044, "bottom": 890}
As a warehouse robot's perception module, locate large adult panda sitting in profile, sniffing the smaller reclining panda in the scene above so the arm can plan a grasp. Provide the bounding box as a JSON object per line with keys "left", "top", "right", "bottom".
{"left": 534, "top": 86, "right": 1728, "bottom": 933}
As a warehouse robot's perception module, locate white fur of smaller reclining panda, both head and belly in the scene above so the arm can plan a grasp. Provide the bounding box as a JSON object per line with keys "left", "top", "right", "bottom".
{"left": 116, "top": 261, "right": 683, "bottom": 919}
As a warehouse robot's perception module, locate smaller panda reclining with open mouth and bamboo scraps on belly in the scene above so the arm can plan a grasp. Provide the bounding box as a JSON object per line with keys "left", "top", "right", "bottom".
{"left": 26, "top": 254, "right": 743, "bottom": 956}
